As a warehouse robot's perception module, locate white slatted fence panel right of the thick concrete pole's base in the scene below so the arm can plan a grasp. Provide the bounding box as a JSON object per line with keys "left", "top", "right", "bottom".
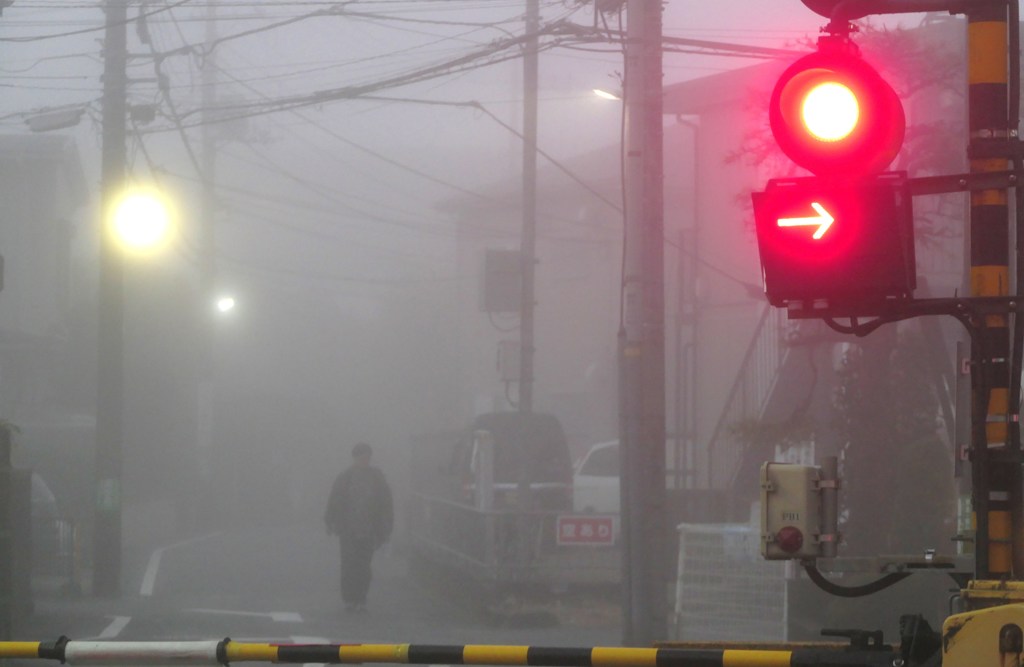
{"left": 675, "top": 524, "right": 788, "bottom": 641}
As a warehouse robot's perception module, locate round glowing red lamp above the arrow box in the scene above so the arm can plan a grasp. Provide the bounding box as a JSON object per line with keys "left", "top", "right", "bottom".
{"left": 768, "top": 47, "right": 906, "bottom": 175}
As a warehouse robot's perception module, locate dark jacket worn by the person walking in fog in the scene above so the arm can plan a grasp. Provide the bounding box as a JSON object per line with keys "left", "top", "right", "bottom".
{"left": 324, "top": 465, "right": 394, "bottom": 547}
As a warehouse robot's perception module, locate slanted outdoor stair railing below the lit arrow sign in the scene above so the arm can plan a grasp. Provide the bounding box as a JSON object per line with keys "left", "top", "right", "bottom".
{"left": 708, "top": 304, "right": 785, "bottom": 489}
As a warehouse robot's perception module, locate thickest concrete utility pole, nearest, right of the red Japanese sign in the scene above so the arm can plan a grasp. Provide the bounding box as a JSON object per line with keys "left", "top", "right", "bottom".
{"left": 618, "top": 0, "right": 668, "bottom": 645}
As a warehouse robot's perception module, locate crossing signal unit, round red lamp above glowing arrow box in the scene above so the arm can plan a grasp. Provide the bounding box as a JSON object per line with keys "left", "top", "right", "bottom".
{"left": 753, "top": 40, "right": 916, "bottom": 316}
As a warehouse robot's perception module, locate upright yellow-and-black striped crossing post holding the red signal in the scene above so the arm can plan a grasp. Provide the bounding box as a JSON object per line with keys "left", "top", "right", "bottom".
{"left": 968, "top": 5, "right": 1024, "bottom": 579}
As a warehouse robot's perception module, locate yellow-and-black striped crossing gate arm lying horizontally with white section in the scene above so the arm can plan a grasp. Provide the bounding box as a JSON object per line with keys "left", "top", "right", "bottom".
{"left": 0, "top": 637, "right": 898, "bottom": 667}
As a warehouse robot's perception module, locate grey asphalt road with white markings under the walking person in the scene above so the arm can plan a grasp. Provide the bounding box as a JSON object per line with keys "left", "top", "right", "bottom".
{"left": 16, "top": 516, "right": 621, "bottom": 647}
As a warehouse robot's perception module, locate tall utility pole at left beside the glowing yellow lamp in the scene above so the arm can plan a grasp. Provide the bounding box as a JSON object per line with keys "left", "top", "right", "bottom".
{"left": 92, "top": 0, "right": 128, "bottom": 597}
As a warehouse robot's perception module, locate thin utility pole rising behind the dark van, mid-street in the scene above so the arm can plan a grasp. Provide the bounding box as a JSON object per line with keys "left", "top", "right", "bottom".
{"left": 519, "top": 0, "right": 541, "bottom": 413}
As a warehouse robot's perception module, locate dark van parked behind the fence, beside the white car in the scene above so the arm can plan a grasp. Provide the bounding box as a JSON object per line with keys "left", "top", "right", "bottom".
{"left": 452, "top": 412, "right": 572, "bottom": 510}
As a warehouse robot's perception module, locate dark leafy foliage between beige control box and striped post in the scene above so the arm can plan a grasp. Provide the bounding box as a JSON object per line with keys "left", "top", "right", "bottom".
{"left": 834, "top": 328, "right": 955, "bottom": 554}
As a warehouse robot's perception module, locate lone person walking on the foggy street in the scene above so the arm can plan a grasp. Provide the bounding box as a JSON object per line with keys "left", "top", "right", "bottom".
{"left": 324, "top": 443, "right": 393, "bottom": 612}
